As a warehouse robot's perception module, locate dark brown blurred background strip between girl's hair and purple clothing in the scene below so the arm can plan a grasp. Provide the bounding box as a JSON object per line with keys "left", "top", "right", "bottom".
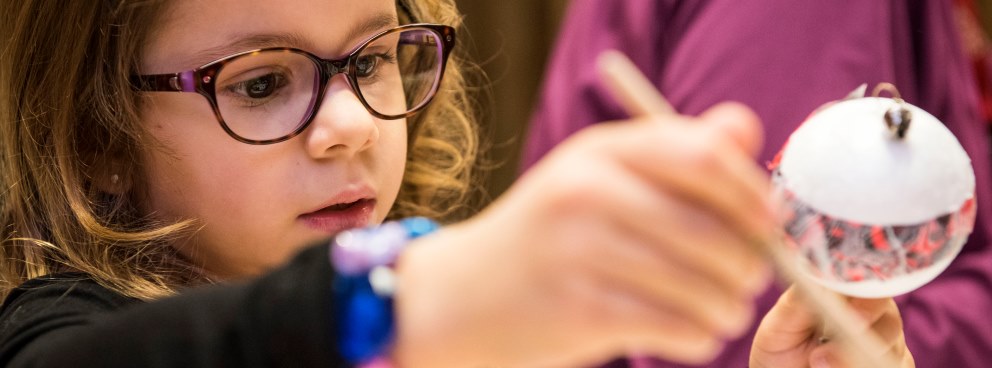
{"left": 456, "top": 0, "right": 568, "bottom": 203}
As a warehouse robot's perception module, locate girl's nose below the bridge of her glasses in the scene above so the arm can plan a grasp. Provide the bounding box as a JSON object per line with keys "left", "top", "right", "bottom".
{"left": 305, "top": 75, "right": 379, "bottom": 158}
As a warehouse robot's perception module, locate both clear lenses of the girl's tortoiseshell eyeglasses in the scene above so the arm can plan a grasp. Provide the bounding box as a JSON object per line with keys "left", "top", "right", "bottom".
{"left": 216, "top": 28, "right": 442, "bottom": 140}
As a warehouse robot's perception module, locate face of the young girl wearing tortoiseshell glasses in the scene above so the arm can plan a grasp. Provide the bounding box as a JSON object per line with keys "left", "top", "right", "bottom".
{"left": 141, "top": 0, "right": 407, "bottom": 277}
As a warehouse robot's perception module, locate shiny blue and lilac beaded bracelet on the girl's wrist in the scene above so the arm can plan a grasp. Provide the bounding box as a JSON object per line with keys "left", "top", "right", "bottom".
{"left": 330, "top": 217, "right": 438, "bottom": 365}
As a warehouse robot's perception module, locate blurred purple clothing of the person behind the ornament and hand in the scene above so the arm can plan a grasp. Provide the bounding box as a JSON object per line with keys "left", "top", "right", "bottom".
{"left": 524, "top": 0, "right": 992, "bottom": 367}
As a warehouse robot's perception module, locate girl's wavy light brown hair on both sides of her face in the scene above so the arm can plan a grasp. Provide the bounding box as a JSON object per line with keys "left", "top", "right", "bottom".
{"left": 0, "top": 0, "right": 478, "bottom": 300}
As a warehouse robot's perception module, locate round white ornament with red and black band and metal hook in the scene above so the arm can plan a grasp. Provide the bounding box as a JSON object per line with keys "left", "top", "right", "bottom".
{"left": 773, "top": 89, "right": 975, "bottom": 298}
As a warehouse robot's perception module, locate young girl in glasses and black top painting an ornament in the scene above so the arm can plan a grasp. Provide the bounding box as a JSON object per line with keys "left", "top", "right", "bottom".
{"left": 0, "top": 0, "right": 911, "bottom": 367}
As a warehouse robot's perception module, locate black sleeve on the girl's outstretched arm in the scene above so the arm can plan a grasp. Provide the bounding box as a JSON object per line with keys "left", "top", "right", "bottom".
{"left": 0, "top": 245, "right": 347, "bottom": 367}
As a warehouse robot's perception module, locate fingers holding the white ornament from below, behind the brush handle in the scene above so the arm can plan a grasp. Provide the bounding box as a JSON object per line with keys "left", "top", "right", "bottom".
{"left": 750, "top": 288, "right": 915, "bottom": 368}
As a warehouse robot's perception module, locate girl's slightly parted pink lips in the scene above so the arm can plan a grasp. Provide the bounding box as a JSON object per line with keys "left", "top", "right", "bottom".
{"left": 299, "top": 187, "right": 376, "bottom": 235}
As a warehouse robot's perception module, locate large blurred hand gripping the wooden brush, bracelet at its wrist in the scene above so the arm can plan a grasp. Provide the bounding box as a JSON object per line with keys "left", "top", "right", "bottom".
{"left": 393, "top": 104, "right": 776, "bottom": 367}
